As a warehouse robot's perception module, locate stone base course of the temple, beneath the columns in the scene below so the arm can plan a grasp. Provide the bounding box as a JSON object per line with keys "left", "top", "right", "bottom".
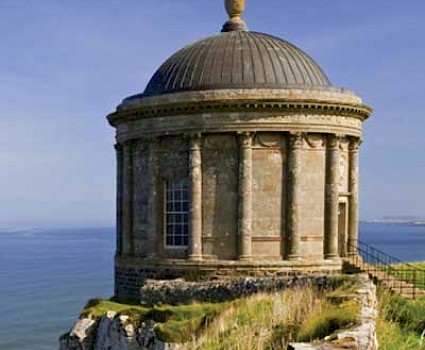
{"left": 115, "top": 256, "right": 342, "bottom": 299}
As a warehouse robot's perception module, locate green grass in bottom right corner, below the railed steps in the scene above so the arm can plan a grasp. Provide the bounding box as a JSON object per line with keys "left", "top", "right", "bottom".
{"left": 377, "top": 290, "right": 425, "bottom": 350}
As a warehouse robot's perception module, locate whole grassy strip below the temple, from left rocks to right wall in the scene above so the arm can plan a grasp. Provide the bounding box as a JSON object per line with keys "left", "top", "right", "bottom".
{"left": 81, "top": 281, "right": 360, "bottom": 350}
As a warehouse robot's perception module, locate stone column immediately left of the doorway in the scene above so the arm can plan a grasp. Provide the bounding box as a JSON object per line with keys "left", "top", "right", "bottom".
{"left": 324, "top": 135, "right": 341, "bottom": 259}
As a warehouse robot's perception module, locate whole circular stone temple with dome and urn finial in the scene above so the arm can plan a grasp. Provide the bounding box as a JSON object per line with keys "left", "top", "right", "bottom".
{"left": 108, "top": 0, "right": 371, "bottom": 297}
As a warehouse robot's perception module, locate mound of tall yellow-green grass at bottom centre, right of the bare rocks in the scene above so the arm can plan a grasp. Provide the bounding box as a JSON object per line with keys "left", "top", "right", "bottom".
{"left": 189, "top": 286, "right": 360, "bottom": 350}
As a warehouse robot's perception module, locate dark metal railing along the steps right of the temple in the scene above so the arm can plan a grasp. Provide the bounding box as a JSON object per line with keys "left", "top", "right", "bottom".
{"left": 348, "top": 241, "right": 425, "bottom": 299}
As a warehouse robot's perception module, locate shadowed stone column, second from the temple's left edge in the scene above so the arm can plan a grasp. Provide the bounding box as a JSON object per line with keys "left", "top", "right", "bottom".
{"left": 122, "top": 142, "right": 133, "bottom": 255}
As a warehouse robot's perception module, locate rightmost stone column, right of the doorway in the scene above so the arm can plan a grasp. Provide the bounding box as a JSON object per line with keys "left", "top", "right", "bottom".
{"left": 347, "top": 138, "right": 360, "bottom": 255}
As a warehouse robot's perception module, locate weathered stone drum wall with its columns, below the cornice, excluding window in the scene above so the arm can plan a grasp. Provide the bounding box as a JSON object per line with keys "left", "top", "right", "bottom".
{"left": 115, "top": 130, "right": 358, "bottom": 297}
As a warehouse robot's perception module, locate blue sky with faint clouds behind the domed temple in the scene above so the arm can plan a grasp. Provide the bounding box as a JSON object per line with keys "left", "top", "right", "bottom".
{"left": 0, "top": 0, "right": 425, "bottom": 227}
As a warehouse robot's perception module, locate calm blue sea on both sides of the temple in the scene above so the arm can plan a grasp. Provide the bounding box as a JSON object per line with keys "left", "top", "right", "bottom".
{"left": 0, "top": 223, "right": 425, "bottom": 350}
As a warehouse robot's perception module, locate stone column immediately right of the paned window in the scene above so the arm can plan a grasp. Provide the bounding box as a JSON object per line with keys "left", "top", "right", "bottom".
{"left": 188, "top": 134, "right": 202, "bottom": 260}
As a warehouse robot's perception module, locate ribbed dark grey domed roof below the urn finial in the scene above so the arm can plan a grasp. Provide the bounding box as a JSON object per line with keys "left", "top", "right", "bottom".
{"left": 142, "top": 30, "right": 331, "bottom": 97}
